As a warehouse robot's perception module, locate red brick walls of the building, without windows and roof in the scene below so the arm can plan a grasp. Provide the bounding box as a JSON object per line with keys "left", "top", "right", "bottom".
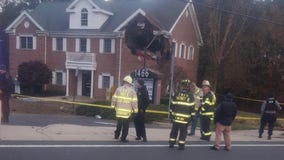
{"left": 9, "top": 7, "right": 199, "bottom": 100}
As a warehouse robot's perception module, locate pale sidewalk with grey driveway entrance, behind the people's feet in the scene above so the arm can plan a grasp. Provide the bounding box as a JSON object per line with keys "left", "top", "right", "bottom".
{"left": 0, "top": 114, "right": 284, "bottom": 143}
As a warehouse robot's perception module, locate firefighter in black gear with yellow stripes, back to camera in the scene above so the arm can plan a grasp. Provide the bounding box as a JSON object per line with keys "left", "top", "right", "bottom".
{"left": 169, "top": 80, "right": 195, "bottom": 150}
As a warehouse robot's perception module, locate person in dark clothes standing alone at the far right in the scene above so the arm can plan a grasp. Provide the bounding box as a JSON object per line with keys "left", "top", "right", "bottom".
{"left": 258, "top": 94, "right": 282, "bottom": 140}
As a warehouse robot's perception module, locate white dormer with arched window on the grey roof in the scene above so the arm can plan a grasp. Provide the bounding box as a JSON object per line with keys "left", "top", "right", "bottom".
{"left": 66, "top": 0, "right": 113, "bottom": 29}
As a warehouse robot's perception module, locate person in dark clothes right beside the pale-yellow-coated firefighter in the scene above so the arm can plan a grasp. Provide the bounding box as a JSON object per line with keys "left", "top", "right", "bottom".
{"left": 134, "top": 80, "right": 150, "bottom": 142}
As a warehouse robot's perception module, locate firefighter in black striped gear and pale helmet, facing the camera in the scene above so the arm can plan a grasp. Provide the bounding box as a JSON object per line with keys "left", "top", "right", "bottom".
{"left": 200, "top": 80, "right": 216, "bottom": 141}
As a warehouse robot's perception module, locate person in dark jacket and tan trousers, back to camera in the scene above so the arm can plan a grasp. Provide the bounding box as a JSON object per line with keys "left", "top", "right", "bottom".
{"left": 211, "top": 93, "right": 237, "bottom": 151}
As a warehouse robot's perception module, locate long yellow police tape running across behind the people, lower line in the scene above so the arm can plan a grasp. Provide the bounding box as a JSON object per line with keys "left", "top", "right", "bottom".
{"left": 13, "top": 94, "right": 284, "bottom": 121}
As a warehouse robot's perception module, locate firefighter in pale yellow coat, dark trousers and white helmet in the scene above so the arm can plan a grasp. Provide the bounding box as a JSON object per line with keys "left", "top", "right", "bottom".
{"left": 112, "top": 75, "right": 138, "bottom": 142}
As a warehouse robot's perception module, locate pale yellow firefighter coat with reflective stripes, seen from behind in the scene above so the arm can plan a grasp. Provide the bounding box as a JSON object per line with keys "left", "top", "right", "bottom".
{"left": 112, "top": 85, "right": 138, "bottom": 119}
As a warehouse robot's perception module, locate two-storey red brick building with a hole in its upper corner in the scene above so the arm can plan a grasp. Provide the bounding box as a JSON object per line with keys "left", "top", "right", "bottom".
{"left": 6, "top": 0, "right": 203, "bottom": 102}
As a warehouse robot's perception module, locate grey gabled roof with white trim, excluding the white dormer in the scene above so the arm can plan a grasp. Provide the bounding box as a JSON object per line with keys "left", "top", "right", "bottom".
{"left": 6, "top": 0, "right": 203, "bottom": 44}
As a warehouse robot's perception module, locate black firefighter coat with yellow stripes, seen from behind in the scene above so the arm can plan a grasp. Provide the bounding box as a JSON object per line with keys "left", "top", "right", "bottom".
{"left": 170, "top": 91, "right": 195, "bottom": 124}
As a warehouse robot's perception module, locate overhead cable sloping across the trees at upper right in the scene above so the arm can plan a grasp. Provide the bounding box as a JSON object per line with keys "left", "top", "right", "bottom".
{"left": 189, "top": 2, "right": 284, "bottom": 27}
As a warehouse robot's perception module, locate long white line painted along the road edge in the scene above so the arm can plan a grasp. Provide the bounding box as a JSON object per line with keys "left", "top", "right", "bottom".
{"left": 0, "top": 144, "right": 284, "bottom": 148}
